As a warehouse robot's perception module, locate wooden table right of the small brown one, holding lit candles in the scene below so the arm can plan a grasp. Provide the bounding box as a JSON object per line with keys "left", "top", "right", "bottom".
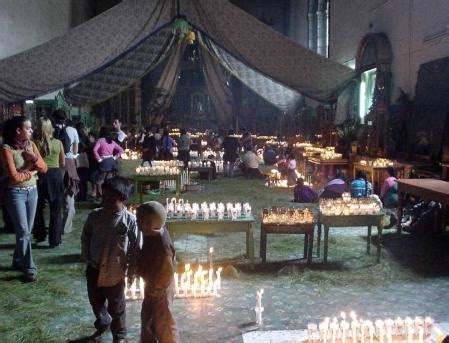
{"left": 318, "top": 212, "right": 384, "bottom": 262}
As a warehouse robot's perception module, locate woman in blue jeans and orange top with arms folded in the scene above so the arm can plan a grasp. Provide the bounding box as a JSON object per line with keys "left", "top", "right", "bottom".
{"left": 0, "top": 116, "right": 47, "bottom": 281}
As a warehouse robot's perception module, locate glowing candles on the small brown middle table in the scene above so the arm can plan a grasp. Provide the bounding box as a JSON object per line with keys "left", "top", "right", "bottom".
{"left": 262, "top": 208, "right": 313, "bottom": 225}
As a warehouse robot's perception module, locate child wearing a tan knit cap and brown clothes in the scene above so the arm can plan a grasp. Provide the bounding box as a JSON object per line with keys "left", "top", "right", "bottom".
{"left": 137, "top": 201, "right": 179, "bottom": 343}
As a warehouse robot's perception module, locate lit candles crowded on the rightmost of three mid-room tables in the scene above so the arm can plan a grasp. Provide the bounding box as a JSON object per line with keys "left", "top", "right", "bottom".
{"left": 320, "top": 198, "right": 382, "bottom": 216}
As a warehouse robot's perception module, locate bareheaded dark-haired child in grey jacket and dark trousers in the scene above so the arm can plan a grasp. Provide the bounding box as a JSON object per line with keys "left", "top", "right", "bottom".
{"left": 81, "top": 176, "right": 140, "bottom": 343}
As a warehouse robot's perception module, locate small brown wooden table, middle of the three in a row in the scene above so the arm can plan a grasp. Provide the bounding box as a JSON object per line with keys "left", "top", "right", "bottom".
{"left": 260, "top": 222, "right": 315, "bottom": 264}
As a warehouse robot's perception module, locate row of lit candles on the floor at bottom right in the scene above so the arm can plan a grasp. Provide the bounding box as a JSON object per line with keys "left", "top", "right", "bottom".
{"left": 307, "top": 312, "right": 433, "bottom": 343}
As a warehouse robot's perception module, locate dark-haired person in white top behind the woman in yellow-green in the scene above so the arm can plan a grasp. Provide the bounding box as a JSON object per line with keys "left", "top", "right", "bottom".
{"left": 53, "top": 109, "right": 80, "bottom": 233}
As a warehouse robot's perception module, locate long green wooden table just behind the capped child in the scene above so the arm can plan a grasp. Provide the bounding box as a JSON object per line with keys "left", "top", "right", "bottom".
{"left": 166, "top": 216, "right": 255, "bottom": 268}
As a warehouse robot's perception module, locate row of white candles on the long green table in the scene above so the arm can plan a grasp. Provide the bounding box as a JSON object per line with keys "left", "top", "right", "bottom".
{"left": 165, "top": 198, "right": 251, "bottom": 220}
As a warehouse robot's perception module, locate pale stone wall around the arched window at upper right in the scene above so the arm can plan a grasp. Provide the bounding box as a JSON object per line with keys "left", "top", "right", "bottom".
{"left": 329, "top": 0, "right": 449, "bottom": 101}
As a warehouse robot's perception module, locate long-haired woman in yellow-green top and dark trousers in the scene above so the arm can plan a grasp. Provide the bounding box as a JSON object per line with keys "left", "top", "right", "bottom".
{"left": 33, "top": 117, "right": 65, "bottom": 248}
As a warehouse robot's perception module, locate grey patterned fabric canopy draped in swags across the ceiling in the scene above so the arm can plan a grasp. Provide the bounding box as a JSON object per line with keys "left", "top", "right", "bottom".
{"left": 0, "top": 0, "right": 354, "bottom": 111}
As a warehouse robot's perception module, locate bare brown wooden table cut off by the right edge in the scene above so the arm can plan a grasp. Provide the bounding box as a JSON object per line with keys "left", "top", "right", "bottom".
{"left": 396, "top": 179, "right": 449, "bottom": 233}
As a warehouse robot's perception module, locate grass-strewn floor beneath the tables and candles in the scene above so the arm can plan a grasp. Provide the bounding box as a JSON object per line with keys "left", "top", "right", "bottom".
{"left": 0, "top": 178, "right": 449, "bottom": 342}
